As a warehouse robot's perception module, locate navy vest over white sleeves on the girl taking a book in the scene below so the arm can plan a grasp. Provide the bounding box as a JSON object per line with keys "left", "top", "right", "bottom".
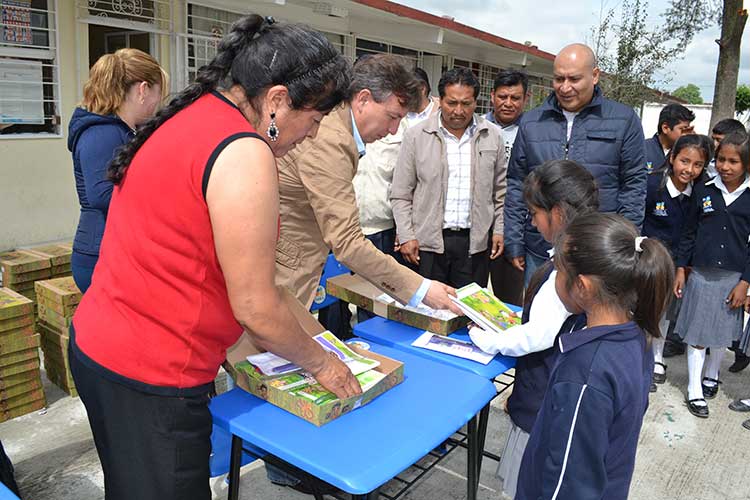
{"left": 508, "top": 265, "right": 586, "bottom": 433}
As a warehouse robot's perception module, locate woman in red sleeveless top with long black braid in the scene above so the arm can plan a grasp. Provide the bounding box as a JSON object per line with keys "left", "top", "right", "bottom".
{"left": 70, "top": 15, "right": 360, "bottom": 500}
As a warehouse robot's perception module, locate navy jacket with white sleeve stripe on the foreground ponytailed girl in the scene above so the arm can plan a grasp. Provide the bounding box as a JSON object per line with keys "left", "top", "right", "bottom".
{"left": 516, "top": 322, "right": 654, "bottom": 500}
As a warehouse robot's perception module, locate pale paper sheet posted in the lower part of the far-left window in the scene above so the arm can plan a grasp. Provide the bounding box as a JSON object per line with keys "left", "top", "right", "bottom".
{"left": 0, "top": 58, "right": 44, "bottom": 125}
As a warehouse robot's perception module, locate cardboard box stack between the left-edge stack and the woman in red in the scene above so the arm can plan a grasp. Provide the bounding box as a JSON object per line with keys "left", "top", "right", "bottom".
{"left": 36, "top": 277, "right": 81, "bottom": 396}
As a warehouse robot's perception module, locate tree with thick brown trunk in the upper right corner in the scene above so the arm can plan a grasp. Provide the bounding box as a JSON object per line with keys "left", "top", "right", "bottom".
{"left": 664, "top": 0, "right": 748, "bottom": 127}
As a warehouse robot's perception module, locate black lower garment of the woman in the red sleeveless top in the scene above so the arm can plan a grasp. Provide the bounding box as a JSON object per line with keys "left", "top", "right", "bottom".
{"left": 68, "top": 339, "right": 212, "bottom": 500}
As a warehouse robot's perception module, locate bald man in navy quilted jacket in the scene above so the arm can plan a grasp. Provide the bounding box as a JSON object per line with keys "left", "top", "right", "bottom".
{"left": 505, "top": 43, "right": 647, "bottom": 284}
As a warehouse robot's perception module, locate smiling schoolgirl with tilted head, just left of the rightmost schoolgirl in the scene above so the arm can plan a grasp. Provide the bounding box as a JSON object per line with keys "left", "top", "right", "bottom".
{"left": 642, "top": 135, "right": 713, "bottom": 392}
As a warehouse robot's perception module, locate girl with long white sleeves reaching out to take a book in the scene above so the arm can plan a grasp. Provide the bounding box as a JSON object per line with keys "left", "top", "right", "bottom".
{"left": 469, "top": 160, "right": 599, "bottom": 497}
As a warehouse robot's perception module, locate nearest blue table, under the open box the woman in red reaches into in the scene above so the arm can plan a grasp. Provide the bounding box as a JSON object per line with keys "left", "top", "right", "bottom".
{"left": 210, "top": 345, "right": 495, "bottom": 500}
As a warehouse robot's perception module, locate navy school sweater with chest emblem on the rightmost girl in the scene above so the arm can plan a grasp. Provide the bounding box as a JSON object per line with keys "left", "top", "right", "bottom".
{"left": 677, "top": 179, "right": 750, "bottom": 282}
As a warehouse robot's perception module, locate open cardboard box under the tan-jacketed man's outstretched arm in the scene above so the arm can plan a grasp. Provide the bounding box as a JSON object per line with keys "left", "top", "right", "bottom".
{"left": 326, "top": 274, "right": 469, "bottom": 335}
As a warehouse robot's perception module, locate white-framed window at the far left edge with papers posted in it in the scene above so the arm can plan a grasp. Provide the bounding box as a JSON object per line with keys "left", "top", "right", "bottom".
{"left": 0, "top": 0, "right": 60, "bottom": 137}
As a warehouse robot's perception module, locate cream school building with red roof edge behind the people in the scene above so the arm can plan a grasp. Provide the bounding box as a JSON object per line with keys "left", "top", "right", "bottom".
{"left": 0, "top": 0, "right": 554, "bottom": 251}
